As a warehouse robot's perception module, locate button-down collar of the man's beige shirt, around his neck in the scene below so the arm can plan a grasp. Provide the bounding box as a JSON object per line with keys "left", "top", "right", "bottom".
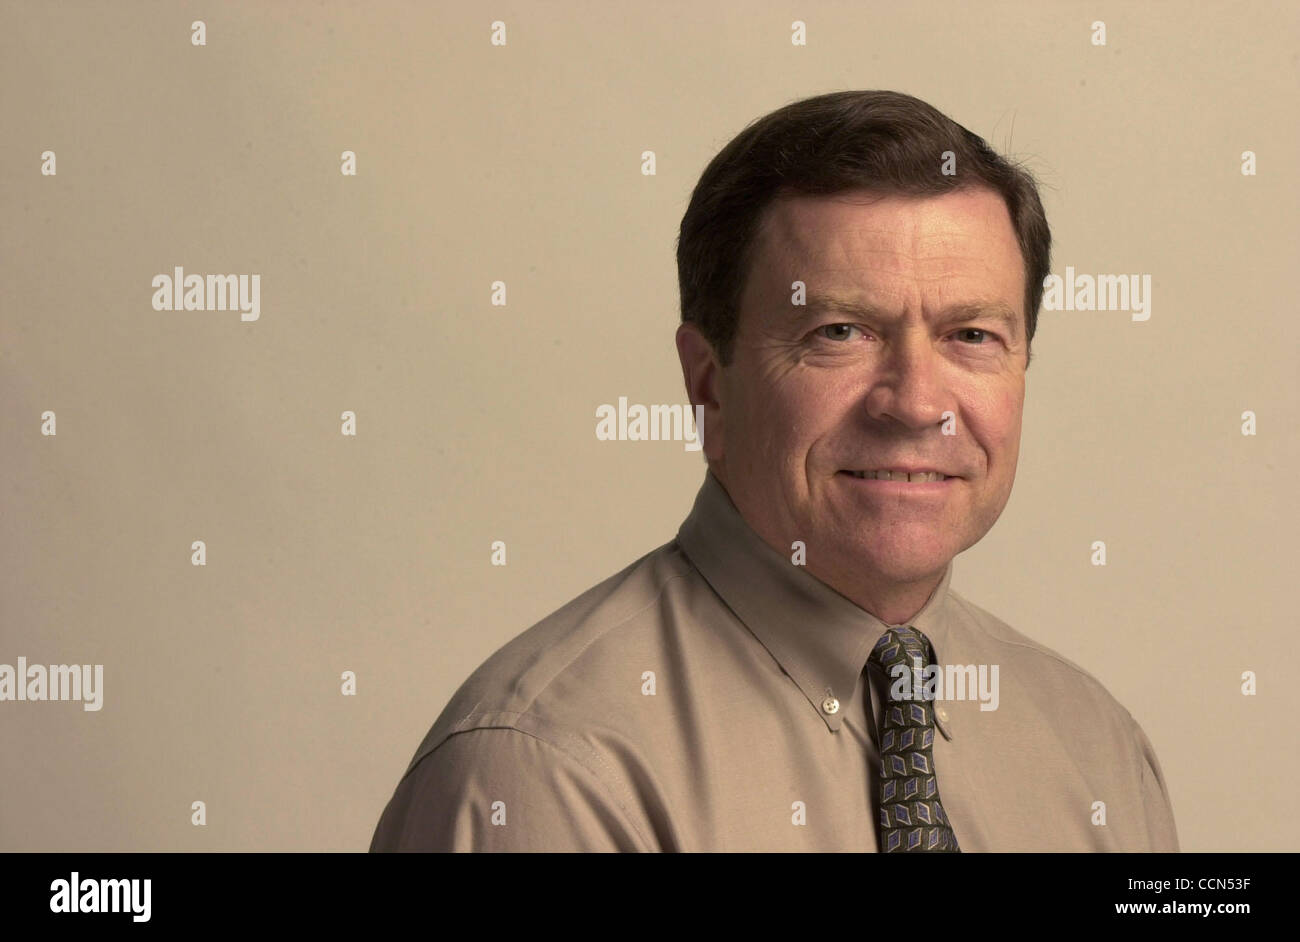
{"left": 677, "top": 472, "right": 953, "bottom": 730}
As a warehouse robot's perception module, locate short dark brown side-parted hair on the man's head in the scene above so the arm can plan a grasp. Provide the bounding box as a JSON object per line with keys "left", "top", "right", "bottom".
{"left": 677, "top": 91, "right": 1052, "bottom": 366}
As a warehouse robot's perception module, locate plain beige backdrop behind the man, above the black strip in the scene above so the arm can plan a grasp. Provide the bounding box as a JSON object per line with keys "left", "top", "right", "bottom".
{"left": 0, "top": 0, "right": 1300, "bottom": 851}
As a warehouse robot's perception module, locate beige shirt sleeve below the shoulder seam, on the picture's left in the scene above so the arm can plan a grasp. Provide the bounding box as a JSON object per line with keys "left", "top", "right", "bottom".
{"left": 371, "top": 728, "right": 650, "bottom": 852}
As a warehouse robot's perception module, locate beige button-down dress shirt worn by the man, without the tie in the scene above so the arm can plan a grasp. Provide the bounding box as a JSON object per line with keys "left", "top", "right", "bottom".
{"left": 371, "top": 472, "right": 1178, "bottom": 852}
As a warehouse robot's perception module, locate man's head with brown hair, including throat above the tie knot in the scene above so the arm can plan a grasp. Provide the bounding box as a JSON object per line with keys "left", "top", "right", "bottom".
{"left": 677, "top": 92, "right": 1050, "bottom": 620}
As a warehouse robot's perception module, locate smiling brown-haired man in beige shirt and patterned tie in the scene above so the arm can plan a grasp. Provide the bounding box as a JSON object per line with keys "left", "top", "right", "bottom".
{"left": 372, "top": 92, "right": 1178, "bottom": 852}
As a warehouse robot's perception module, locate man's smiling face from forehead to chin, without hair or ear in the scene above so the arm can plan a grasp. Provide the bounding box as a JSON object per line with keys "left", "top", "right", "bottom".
{"left": 705, "top": 190, "right": 1026, "bottom": 585}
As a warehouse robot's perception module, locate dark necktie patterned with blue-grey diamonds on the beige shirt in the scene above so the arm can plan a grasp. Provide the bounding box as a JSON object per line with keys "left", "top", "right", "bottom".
{"left": 870, "top": 625, "right": 961, "bottom": 854}
